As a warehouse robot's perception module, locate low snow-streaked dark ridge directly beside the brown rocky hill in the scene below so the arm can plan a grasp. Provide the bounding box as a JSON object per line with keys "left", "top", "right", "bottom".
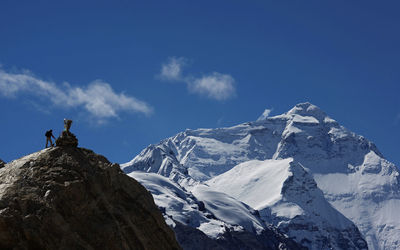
{"left": 129, "top": 172, "right": 301, "bottom": 249}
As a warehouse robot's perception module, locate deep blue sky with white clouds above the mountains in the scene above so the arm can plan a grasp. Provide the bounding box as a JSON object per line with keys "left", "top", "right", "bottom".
{"left": 0, "top": 0, "right": 400, "bottom": 166}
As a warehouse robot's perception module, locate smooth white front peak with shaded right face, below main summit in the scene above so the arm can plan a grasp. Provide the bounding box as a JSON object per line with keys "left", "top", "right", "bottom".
{"left": 206, "top": 158, "right": 367, "bottom": 249}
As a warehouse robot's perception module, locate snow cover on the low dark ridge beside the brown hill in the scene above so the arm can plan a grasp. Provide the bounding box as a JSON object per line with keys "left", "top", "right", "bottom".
{"left": 129, "top": 171, "right": 265, "bottom": 238}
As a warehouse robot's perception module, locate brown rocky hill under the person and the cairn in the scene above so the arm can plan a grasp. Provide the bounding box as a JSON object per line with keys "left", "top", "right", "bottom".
{"left": 0, "top": 147, "right": 180, "bottom": 249}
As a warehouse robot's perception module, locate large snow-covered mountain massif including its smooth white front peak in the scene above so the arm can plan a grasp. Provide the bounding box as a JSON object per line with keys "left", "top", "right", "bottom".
{"left": 122, "top": 103, "right": 400, "bottom": 249}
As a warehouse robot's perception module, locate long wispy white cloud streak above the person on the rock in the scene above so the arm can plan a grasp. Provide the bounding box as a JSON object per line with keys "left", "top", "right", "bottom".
{"left": 0, "top": 69, "right": 152, "bottom": 119}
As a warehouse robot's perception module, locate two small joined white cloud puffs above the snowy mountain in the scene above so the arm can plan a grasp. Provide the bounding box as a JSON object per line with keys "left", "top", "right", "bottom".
{"left": 159, "top": 57, "right": 236, "bottom": 101}
